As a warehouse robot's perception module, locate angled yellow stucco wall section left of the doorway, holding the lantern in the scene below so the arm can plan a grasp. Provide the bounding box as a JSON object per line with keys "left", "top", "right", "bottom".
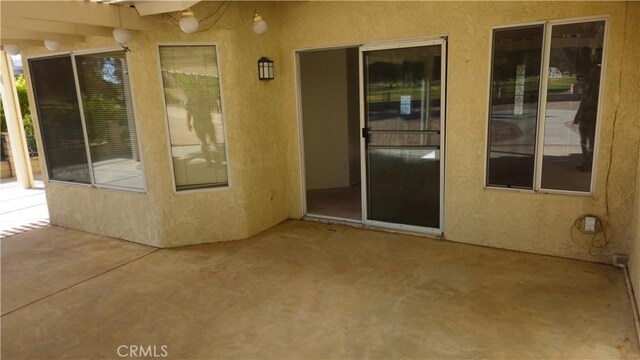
{"left": 23, "top": 2, "right": 288, "bottom": 247}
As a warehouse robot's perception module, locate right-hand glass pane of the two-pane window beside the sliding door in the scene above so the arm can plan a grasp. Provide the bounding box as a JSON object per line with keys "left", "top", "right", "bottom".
{"left": 541, "top": 21, "right": 605, "bottom": 192}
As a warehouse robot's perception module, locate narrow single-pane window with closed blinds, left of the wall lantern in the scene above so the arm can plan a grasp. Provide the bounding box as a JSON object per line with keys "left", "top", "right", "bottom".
{"left": 159, "top": 45, "right": 228, "bottom": 190}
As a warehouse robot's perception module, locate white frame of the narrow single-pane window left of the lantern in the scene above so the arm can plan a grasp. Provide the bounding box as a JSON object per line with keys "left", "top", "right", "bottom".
{"left": 156, "top": 42, "right": 231, "bottom": 195}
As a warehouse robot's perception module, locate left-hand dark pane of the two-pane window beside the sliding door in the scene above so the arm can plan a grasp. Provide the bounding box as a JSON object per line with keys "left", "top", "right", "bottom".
{"left": 487, "top": 25, "right": 543, "bottom": 189}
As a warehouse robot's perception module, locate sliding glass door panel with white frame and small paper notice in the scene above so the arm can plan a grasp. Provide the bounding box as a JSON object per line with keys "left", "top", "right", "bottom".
{"left": 360, "top": 39, "right": 446, "bottom": 234}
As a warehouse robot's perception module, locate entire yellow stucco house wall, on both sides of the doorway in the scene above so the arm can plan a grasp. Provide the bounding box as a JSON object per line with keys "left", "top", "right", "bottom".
{"left": 21, "top": 2, "right": 640, "bottom": 262}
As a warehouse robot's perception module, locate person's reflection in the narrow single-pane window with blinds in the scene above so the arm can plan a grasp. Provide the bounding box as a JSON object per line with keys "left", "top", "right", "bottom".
{"left": 187, "top": 76, "right": 216, "bottom": 165}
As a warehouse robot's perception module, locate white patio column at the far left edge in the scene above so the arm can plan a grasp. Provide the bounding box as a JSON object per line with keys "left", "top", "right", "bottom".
{"left": 0, "top": 51, "right": 33, "bottom": 189}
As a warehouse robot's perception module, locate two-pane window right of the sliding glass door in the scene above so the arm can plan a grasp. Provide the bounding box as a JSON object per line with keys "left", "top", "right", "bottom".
{"left": 486, "top": 20, "right": 605, "bottom": 193}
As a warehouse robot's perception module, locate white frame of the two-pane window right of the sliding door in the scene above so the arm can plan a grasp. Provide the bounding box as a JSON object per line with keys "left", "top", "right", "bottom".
{"left": 484, "top": 16, "right": 609, "bottom": 197}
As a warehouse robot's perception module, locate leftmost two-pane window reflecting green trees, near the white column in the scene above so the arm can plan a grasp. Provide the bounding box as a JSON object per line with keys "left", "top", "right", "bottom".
{"left": 29, "top": 50, "right": 144, "bottom": 190}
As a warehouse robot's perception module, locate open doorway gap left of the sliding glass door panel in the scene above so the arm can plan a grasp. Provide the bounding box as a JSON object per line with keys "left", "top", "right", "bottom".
{"left": 298, "top": 47, "right": 362, "bottom": 222}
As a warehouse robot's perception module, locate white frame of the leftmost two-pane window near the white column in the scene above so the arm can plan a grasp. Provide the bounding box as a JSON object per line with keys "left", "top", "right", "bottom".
{"left": 25, "top": 46, "right": 147, "bottom": 194}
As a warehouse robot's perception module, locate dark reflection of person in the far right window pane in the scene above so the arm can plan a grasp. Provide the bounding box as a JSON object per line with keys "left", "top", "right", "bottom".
{"left": 573, "top": 48, "right": 602, "bottom": 171}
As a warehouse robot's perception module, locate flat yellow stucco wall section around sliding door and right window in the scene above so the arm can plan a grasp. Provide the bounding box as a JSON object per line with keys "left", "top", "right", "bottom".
{"left": 280, "top": 2, "right": 640, "bottom": 261}
